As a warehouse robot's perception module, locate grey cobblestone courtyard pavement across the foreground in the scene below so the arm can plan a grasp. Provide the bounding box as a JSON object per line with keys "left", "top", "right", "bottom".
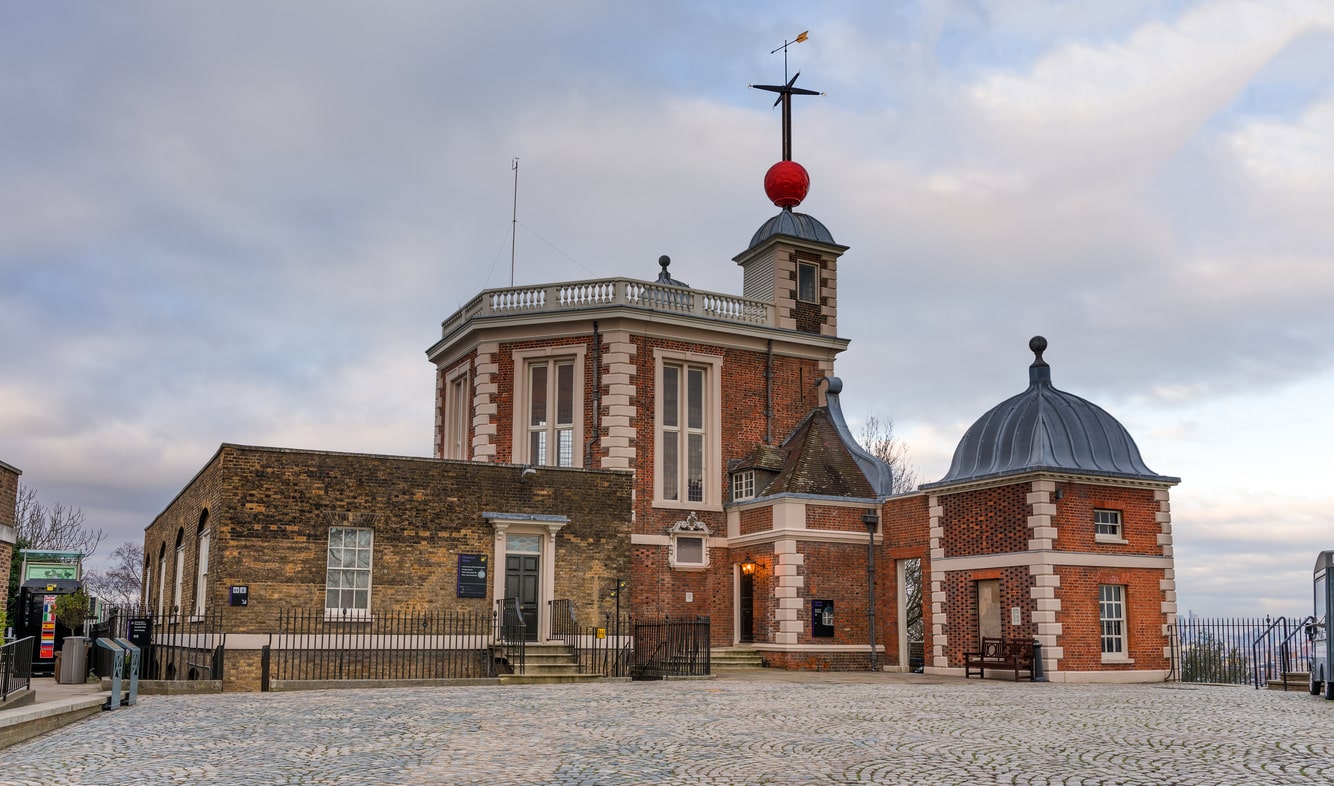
{"left": 0, "top": 675, "right": 1334, "bottom": 786}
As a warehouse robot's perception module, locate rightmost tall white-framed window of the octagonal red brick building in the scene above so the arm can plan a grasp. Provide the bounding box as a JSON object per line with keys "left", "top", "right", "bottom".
{"left": 660, "top": 364, "right": 708, "bottom": 502}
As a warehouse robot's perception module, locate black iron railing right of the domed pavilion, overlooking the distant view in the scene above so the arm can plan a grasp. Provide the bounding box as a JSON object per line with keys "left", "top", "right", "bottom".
{"left": 1171, "top": 617, "right": 1311, "bottom": 689}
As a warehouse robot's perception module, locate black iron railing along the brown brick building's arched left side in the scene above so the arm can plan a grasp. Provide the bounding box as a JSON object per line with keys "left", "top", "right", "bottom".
{"left": 88, "top": 606, "right": 227, "bottom": 681}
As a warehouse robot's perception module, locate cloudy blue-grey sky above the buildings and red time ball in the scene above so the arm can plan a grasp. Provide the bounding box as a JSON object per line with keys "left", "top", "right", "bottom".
{"left": 0, "top": 0, "right": 1334, "bottom": 615}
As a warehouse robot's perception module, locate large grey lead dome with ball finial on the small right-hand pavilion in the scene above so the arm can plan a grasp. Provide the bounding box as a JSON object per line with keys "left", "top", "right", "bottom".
{"left": 922, "top": 336, "right": 1178, "bottom": 488}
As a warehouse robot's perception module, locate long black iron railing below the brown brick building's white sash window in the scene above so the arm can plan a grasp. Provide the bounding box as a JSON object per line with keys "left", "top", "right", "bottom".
{"left": 263, "top": 609, "right": 496, "bottom": 681}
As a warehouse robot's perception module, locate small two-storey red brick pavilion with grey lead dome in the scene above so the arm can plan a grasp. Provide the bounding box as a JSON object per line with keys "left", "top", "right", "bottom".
{"left": 922, "top": 336, "right": 1178, "bottom": 681}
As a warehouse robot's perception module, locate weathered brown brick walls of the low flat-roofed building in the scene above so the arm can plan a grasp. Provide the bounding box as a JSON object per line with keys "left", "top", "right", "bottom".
{"left": 144, "top": 446, "right": 631, "bottom": 633}
